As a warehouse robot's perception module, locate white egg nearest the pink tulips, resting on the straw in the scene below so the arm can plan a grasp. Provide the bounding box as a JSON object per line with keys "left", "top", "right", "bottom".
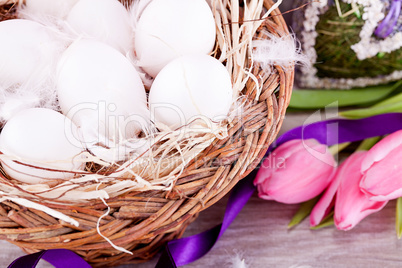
{"left": 149, "top": 54, "right": 233, "bottom": 128}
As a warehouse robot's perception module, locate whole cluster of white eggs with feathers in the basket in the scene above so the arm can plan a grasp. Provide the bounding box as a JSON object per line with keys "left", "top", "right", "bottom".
{"left": 0, "top": 0, "right": 232, "bottom": 183}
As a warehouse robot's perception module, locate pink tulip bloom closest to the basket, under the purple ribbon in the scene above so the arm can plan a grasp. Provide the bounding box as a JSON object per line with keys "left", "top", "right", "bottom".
{"left": 254, "top": 139, "right": 336, "bottom": 204}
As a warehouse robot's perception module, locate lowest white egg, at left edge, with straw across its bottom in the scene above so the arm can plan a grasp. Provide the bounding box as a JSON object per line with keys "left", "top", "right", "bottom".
{"left": 0, "top": 108, "right": 85, "bottom": 183}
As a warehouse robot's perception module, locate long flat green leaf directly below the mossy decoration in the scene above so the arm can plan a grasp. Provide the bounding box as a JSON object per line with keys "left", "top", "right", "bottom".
{"left": 289, "top": 81, "right": 402, "bottom": 109}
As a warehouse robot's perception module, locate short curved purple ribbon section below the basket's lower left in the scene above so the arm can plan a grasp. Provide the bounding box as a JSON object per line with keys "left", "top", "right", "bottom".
{"left": 8, "top": 249, "right": 91, "bottom": 268}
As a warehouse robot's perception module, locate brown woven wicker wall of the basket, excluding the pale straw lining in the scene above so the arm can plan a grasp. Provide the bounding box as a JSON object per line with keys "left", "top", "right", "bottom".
{"left": 0, "top": 0, "right": 294, "bottom": 267}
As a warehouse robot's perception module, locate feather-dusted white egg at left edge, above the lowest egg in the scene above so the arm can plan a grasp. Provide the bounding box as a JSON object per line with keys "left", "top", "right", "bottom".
{"left": 0, "top": 20, "right": 67, "bottom": 122}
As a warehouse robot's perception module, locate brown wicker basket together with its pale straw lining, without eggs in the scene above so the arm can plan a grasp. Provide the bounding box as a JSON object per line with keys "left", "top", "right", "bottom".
{"left": 0, "top": 0, "right": 294, "bottom": 267}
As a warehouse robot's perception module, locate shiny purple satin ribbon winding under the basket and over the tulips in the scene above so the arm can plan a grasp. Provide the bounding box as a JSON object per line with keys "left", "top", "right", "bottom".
{"left": 9, "top": 113, "right": 402, "bottom": 268}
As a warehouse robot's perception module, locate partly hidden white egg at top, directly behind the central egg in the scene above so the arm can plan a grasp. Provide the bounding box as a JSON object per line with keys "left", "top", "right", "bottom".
{"left": 67, "top": 0, "right": 132, "bottom": 54}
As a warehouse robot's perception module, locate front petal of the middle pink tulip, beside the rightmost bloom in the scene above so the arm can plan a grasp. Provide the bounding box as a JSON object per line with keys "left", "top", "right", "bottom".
{"left": 334, "top": 151, "right": 387, "bottom": 230}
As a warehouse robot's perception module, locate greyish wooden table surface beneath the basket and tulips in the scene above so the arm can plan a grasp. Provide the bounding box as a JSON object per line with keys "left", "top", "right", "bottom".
{"left": 0, "top": 113, "right": 402, "bottom": 268}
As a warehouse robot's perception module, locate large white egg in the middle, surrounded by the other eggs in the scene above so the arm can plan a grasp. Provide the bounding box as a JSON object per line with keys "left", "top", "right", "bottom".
{"left": 57, "top": 40, "right": 149, "bottom": 155}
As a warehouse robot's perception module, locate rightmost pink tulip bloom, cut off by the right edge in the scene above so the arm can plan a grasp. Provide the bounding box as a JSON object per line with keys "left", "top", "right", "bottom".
{"left": 360, "top": 130, "right": 402, "bottom": 201}
